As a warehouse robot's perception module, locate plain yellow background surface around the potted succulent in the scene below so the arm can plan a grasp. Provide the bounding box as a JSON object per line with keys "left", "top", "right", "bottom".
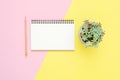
{"left": 35, "top": 0, "right": 120, "bottom": 80}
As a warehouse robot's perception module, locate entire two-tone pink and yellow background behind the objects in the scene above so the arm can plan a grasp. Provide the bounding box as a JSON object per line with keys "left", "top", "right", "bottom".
{"left": 0, "top": 0, "right": 120, "bottom": 80}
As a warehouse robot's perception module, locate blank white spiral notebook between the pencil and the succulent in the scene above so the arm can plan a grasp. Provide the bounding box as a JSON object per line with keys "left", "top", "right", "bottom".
{"left": 31, "top": 20, "right": 75, "bottom": 50}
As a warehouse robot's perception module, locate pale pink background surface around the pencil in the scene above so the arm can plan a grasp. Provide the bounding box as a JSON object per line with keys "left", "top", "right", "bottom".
{"left": 0, "top": 0, "right": 71, "bottom": 80}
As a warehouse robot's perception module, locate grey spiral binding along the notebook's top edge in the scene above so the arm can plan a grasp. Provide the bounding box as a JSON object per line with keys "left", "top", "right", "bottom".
{"left": 31, "top": 20, "right": 74, "bottom": 24}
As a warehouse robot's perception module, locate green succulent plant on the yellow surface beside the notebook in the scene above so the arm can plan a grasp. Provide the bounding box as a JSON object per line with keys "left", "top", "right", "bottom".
{"left": 79, "top": 20, "right": 104, "bottom": 47}
